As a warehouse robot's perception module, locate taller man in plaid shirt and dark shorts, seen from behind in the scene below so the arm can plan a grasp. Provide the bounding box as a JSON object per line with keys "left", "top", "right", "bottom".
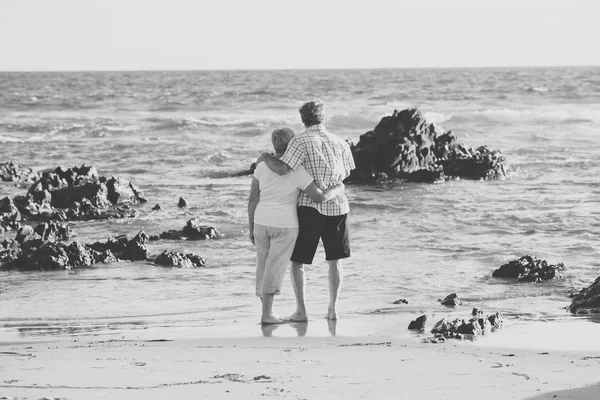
{"left": 257, "top": 100, "right": 355, "bottom": 321}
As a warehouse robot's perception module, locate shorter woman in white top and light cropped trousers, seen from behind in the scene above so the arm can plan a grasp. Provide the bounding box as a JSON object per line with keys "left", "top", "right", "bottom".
{"left": 248, "top": 128, "right": 344, "bottom": 324}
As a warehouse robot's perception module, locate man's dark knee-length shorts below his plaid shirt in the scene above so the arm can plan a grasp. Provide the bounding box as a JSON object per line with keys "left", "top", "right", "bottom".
{"left": 291, "top": 206, "right": 350, "bottom": 264}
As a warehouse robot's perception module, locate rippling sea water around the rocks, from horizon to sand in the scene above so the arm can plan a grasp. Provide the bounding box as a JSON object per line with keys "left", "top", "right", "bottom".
{"left": 0, "top": 67, "right": 600, "bottom": 341}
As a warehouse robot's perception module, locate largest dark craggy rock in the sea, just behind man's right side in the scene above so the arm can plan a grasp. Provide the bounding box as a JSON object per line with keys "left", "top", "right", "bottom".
{"left": 349, "top": 109, "right": 507, "bottom": 182}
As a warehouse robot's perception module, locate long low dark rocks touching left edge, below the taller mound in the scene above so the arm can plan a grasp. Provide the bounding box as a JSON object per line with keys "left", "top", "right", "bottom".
{"left": 0, "top": 230, "right": 148, "bottom": 270}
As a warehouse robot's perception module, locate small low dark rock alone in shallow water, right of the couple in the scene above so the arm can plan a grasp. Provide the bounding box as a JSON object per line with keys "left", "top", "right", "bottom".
{"left": 492, "top": 255, "right": 565, "bottom": 282}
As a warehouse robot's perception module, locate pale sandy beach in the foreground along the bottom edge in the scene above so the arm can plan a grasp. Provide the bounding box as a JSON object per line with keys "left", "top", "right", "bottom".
{"left": 0, "top": 315, "right": 600, "bottom": 400}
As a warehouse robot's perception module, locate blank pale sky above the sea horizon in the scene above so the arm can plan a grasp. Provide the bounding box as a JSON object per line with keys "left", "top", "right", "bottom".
{"left": 0, "top": 0, "right": 600, "bottom": 71}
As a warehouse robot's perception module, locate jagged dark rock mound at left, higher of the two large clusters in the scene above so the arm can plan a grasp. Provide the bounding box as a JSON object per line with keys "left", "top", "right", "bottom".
{"left": 14, "top": 165, "right": 146, "bottom": 221}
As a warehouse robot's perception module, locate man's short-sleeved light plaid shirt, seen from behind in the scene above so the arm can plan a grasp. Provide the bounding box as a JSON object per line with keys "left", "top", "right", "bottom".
{"left": 280, "top": 124, "right": 355, "bottom": 215}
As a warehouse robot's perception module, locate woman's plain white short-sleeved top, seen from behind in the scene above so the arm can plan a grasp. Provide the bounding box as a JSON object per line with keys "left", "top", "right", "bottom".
{"left": 254, "top": 162, "right": 313, "bottom": 228}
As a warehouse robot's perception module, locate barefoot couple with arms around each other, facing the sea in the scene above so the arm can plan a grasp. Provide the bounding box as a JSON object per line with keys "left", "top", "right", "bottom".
{"left": 248, "top": 100, "right": 354, "bottom": 324}
